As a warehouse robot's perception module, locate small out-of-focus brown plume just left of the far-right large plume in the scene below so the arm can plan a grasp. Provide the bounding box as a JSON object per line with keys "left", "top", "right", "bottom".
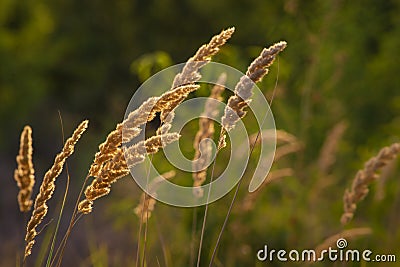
{"left": 318, "top": 121, "right": 347, "bottom": 176}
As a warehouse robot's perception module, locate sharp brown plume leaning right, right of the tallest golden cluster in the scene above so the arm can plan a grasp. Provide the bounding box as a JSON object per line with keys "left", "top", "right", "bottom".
{"left": 221, "top": 41, "right": 287, "bottom": 136}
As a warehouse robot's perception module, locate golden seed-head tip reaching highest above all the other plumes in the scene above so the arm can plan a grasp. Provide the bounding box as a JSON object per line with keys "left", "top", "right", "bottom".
{"left": 172, "top": 27, "right": 235, "bottom": 88}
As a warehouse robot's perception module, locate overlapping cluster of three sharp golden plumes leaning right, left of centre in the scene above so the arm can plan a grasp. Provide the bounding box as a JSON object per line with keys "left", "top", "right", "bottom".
{"left": 78, "top": 28, "right": 234, "bottom": 218}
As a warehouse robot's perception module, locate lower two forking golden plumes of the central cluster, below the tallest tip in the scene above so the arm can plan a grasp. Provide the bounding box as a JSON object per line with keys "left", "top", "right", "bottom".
{"left": 82, "top": 84, "right": 199, "bottom": 214}
